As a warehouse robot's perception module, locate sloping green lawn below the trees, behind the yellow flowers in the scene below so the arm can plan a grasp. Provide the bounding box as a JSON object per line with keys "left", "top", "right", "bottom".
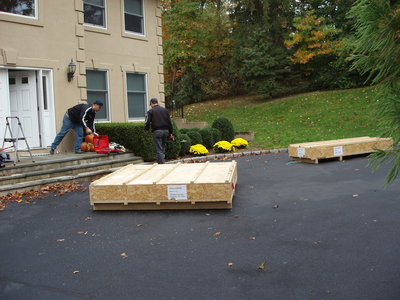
{"left": 185, "top": 87, "right": 379, "bottom": 149}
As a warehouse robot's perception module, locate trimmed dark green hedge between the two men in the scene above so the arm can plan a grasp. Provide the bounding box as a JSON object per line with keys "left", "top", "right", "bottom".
{"left": 96, "top": 123, "right": 156, "bottom": 161}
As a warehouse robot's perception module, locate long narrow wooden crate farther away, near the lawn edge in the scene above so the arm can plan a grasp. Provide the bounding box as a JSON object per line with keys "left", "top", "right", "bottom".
{"left": 288, "top": 136, "right": 393, "bottom": 164}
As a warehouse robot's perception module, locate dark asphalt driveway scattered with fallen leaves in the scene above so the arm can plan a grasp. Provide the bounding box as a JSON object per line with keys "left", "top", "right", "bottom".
{"left": 0, "top": 153, "right": 400, "bottom": 300}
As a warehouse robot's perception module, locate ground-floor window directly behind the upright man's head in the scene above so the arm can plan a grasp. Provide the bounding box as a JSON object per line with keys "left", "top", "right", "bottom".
{"left": 126, "top": 73, "right": 147, "bottom": 120}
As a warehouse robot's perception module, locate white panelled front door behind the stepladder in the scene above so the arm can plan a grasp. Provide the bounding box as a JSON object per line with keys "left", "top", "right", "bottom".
{"left": 8, "top": 71, "right": 41, "bottom": 149}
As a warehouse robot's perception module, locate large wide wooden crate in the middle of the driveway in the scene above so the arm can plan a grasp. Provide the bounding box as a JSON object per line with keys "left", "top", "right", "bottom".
{"left": 89, "top": 161, "right": 237, "bottom": 210}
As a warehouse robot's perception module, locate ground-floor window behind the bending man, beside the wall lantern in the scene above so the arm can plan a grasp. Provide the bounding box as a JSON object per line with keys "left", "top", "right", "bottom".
{"left": 86, "top": 70, "right": 109, "bottom": 121}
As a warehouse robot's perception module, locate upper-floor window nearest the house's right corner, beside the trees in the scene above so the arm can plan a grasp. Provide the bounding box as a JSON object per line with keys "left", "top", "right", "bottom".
{"left": 124, "top": 0, "right": 144, "bottom": 34}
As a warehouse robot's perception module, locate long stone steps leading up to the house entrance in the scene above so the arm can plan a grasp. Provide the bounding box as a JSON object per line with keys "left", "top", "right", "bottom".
{"left": 0, "top": 153, "right": 143, "bottom": 196}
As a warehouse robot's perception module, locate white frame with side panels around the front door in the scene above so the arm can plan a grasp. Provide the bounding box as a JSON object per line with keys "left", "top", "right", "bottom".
{"left": 0, "top": 66, "right": 56, "bottom": 149}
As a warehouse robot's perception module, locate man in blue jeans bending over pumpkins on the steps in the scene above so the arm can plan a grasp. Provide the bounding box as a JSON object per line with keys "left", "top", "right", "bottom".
{"left": 50, "top": 101, "right": 103, "bottom": 154}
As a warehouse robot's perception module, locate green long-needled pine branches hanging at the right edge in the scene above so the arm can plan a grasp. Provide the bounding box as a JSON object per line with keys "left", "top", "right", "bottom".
{"left": 349, "top": 0, "right": 400, "bottom": 186}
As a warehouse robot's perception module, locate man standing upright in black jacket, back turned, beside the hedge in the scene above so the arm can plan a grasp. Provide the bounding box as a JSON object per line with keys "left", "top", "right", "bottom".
{"left": 145, "top": 98, "right": 172, "bottom": 164}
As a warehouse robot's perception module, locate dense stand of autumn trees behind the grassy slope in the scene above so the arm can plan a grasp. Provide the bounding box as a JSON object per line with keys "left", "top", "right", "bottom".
{"left": 162, "top": 0, "right": 366, "bottom": 103}
